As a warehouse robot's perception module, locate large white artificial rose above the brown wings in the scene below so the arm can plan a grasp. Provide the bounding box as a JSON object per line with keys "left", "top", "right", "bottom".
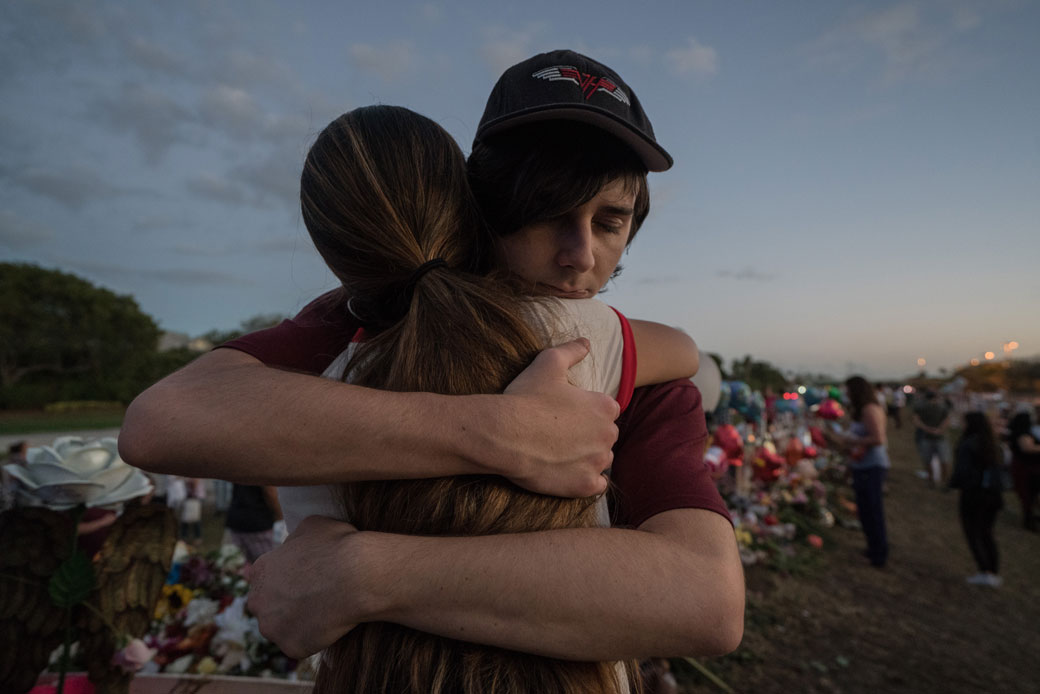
{"left": 4, "top": 436, "right": 152, "bottom": 511}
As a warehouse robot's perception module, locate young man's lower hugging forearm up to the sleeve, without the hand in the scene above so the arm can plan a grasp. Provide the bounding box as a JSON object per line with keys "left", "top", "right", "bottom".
{"left": 356, "top": 511, "right": 744, "bottom": 661}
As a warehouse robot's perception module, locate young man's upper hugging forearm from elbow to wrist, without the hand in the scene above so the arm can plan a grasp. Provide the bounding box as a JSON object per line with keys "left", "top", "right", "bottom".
{"left": 120, "top": 350, "right": 493, "bottom": 485}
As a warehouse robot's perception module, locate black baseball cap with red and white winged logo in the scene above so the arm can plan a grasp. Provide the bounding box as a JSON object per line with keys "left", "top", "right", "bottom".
{"left": 474, "top": 50, "right": 672, "bottom": 171}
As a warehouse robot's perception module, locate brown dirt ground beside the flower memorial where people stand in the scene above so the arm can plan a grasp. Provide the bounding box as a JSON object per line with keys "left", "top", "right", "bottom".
{"left": 679, "top": 420, "right": 1040, "bottom": 694}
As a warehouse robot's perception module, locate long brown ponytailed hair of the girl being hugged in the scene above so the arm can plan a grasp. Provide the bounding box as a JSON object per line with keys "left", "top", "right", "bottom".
{"left": 301, "top": 106, "right": 639, "bottom": 694}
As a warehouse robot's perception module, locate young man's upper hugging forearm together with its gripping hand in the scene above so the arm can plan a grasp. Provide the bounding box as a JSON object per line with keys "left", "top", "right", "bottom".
{"left": 120, "top": 340, "right": 618, "bottom": 496}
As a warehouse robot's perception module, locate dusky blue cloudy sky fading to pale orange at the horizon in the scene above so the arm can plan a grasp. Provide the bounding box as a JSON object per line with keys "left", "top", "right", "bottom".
{"left": 0, "top": 0, "right": 1040, "bottom": 379}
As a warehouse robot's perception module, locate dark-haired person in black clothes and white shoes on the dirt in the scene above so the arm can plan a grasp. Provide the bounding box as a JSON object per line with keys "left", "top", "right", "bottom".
{"left": 950, "top": 412, "right": 1004, "bottom": 588}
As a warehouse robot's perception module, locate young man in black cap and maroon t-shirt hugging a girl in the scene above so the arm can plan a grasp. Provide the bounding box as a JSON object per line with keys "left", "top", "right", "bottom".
{"left": 121, "top": 51, "right": 744, "bottom": 660}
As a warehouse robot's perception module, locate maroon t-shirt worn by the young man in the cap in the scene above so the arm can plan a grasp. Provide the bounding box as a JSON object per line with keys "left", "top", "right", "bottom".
{"left": 220, "top": 289, "right": 730, "bottom": 528}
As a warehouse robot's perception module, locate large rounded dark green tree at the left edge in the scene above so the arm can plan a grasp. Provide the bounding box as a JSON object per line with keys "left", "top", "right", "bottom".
{"left": 0, "top": 263, "right": 159, "bottom": 407}
